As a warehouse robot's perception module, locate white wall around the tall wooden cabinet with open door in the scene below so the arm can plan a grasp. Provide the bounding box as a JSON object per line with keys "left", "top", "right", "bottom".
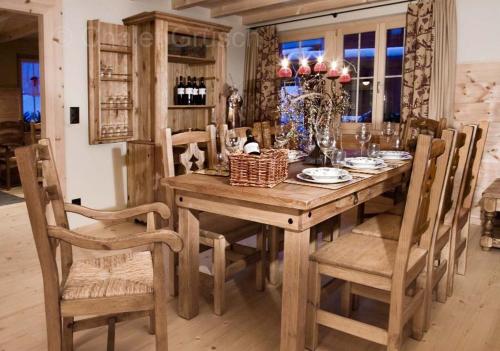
{"left": 63, "top": 0, "right": 245, "bottom": 226}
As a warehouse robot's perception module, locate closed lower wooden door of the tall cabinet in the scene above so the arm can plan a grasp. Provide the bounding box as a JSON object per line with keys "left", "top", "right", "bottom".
{"left": 127, "top": 141, "right": 155, "bottom": 219}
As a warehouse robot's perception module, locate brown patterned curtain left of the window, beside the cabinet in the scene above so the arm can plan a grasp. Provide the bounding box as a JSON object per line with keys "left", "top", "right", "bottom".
{"left": 244, "top": 26, "right": 279, "bottom": 126}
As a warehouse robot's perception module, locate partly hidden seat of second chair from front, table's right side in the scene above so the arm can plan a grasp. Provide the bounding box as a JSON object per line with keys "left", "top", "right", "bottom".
{"left": 352, "top": 213, "right": 402, "bottom": 240}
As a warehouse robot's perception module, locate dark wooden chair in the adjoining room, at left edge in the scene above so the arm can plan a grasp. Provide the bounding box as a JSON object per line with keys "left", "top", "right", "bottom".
{"left": 0, "top": 121, "right": 24, "bottom": 190}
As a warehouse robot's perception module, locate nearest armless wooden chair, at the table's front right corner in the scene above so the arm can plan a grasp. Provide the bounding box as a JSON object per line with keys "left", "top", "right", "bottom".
{"left": 306, "top": 135, "right": 449, "bottom": 350}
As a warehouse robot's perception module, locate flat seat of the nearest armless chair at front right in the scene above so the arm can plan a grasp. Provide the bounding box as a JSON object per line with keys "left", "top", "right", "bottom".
{"left": 311, "top": 233, "right": 427, "bottom": 278}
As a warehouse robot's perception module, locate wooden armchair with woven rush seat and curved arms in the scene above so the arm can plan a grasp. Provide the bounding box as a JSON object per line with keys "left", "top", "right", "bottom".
{"left": 16, "top": 139, "right": 182, "bottom": 351}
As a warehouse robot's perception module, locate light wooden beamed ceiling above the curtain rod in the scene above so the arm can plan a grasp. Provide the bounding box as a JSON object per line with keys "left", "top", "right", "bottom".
{"left": 172, "top": 0, "right": 387, "bottom": 25}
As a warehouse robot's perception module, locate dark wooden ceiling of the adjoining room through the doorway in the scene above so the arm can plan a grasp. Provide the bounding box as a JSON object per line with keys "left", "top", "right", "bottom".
{"left": 0, "top": 10, "right": 38, "bottom": 43}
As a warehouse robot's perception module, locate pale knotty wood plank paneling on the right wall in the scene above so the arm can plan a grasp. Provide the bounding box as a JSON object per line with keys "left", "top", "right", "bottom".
{"left": 453, "top": 62, "right": 500, "bottom": 223}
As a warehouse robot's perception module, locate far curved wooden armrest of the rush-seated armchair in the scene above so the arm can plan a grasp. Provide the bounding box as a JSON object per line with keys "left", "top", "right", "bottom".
{"left": 64, "top": 202, "right": 170, "bottom": 221}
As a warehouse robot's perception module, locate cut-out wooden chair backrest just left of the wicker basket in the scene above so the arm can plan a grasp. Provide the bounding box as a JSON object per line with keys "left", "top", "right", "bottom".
{"left": 162, "top": 125, "right": 217, "bottom": 177}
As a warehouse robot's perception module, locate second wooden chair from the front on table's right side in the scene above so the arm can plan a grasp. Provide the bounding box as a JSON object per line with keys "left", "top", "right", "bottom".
{"left": 352, "top": 126, "right": 476, "bottom": 330}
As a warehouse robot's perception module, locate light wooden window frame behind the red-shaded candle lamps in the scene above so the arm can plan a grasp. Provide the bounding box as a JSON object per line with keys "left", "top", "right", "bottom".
{"left": 278, "top": 14, "right": 406, "bottom": 133}
